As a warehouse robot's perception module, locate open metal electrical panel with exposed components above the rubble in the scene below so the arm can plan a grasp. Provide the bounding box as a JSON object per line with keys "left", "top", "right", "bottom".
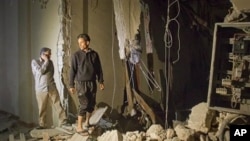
{"left": 207, "top": 22, "right": 250, "bottom": 115}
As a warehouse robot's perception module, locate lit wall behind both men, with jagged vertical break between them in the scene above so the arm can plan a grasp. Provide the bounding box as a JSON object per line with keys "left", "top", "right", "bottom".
{"left": 0, "top": 0, "right": 126, "bottom": 124}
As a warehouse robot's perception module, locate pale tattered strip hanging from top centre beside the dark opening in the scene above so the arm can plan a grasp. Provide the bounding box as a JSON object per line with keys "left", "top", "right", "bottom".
{"left": 113, "top": 0, "right": 141, "bottom": 59}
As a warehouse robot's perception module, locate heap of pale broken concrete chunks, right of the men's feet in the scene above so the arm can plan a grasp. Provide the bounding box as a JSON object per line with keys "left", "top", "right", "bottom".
{"left": 98, "top": 103, "right": 221, "bottom": 141}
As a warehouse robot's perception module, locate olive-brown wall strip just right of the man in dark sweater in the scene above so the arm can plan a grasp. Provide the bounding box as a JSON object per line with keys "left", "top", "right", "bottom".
{"left": 87, "top": 0, "right": 125, "bottom": 109}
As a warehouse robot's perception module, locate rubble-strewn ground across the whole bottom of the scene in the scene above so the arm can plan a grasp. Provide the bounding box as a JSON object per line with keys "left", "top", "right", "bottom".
{"left": 0, "top": 103, "right": 245, "bottom": 141}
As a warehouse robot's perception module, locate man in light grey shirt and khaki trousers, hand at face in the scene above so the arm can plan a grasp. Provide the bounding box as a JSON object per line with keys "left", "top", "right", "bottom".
{"left": 31, "top": 47, "right": 68, "bottom": 129}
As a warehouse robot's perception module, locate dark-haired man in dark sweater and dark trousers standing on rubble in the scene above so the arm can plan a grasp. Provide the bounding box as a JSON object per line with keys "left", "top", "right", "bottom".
{"left": 69, "top": 34, "right": 104, "bottom": 132}
